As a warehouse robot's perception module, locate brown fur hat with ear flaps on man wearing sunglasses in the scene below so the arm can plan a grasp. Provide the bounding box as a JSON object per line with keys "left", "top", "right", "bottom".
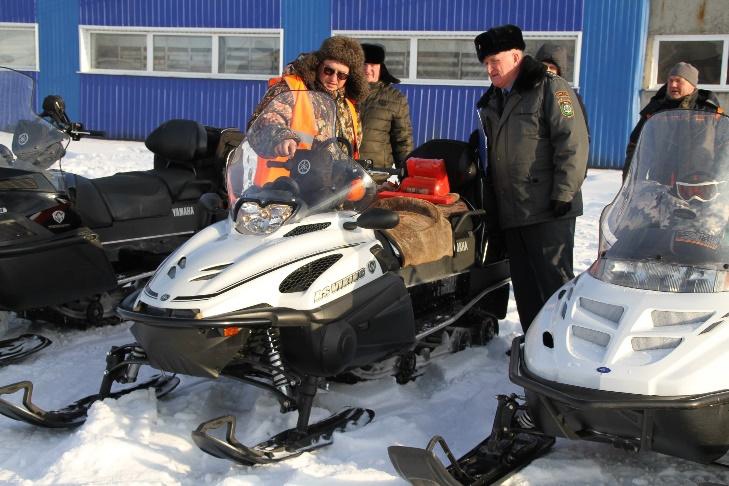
{"left": 291, "top": 35, "right": 369, "bottom": 102}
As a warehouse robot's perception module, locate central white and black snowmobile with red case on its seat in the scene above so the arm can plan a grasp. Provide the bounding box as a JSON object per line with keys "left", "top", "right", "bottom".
{"left": 0, "top": 91, "right": 509, "bottom": 465}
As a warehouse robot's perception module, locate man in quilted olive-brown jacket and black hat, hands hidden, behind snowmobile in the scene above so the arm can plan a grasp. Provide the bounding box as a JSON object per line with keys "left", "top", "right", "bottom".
{"left": 359, "top": 44, "right": 413, "bottom": 168}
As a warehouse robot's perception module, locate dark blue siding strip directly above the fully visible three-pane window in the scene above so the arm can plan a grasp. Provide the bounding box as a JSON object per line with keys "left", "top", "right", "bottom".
{"left": 79, "top": 0, "right": 278, "bottom": 29}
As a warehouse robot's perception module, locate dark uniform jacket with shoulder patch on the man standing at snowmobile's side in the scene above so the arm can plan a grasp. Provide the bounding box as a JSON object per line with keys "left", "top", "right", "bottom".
{"left": 477, "top": 56, "right": 589, "bottom": 229}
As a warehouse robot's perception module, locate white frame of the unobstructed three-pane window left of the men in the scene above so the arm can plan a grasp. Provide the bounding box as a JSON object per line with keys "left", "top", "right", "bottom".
{"left": 78, "top": 25, "right": 284, "bottom": 80}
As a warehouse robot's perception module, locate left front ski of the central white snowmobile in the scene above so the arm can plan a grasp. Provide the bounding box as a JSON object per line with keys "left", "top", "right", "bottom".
{"left": 0, "top": 375, "right": 180, "bottom": 429}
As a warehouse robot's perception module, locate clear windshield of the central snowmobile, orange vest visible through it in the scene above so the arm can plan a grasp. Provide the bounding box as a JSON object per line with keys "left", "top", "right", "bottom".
{"left": 226, "top": 91, "right": 376, "bottom": 234}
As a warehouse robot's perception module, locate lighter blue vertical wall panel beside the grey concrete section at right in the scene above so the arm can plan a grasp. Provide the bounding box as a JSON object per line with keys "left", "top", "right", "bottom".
{"left": 580, "top": 0, "right": 649, "bottom": 169}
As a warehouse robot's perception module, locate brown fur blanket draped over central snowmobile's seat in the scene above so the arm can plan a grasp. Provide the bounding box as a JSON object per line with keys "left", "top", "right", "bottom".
{"left": 375, "top": 197, "right": 453, "bottom": 267}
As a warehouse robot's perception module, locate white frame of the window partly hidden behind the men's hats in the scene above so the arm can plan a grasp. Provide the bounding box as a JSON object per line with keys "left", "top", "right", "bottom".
{"left": 332, "top": 30, "right": 582, "bottom": 88}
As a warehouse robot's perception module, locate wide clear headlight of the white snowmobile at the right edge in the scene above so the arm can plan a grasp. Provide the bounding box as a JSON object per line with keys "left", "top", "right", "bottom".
{"left": 588, "top": 258, "right": 729, "bottom": 293}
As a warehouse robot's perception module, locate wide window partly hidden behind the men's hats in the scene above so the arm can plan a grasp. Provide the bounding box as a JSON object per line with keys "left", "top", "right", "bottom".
{"left": 335, "top": 31, "right": 581, "bottom": 85}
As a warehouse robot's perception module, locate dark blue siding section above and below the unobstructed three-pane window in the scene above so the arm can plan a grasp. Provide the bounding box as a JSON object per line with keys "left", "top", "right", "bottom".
{"left": 75, "top": 0, "right": 281, "bottom": 140}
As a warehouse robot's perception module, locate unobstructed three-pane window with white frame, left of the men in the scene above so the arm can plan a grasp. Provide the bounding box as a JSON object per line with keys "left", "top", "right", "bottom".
{"left": 81, "top": 26, "right": 282, "bottom": 79}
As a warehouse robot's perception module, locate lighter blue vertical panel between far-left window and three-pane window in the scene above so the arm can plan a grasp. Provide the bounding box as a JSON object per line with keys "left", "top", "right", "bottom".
{"left": 36, "top": 0, "right": 80, "bottom": 119}
